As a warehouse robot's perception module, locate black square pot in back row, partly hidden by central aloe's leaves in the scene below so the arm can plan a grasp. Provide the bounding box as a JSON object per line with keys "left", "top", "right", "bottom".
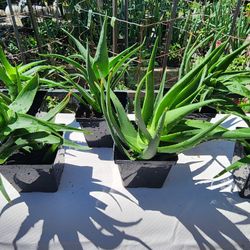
{"left": 76, "top": 91, "right": 127, "bottom": 148}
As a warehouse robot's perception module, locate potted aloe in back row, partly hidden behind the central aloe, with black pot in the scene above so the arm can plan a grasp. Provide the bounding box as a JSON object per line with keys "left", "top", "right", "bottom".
{"left": 45, "top": 18, "right": 141, "bottom": 147}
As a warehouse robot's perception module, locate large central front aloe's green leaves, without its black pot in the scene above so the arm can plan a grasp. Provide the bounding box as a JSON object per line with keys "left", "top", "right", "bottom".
{"left": 102, "top": 38, "right": 250, "bottom": 160}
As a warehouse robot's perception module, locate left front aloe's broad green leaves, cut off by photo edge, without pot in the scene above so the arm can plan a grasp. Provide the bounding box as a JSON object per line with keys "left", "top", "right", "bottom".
{"left": 0, "top": 76, "right": 90, "bottom": 199}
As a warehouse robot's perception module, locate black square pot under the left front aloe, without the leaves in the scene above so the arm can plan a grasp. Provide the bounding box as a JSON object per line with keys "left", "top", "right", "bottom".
{"left": 0, "top": 148, "right": 64, "bottom": 192}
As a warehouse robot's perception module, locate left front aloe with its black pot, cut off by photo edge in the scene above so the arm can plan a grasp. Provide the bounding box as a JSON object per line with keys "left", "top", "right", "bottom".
{"left": 0, "top": 76, "right": 87, "bottom": 201}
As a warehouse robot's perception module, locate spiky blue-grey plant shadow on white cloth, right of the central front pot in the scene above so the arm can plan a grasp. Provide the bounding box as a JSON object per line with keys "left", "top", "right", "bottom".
{"left": 129, "top": 146, "right": 250, "bottom": 250}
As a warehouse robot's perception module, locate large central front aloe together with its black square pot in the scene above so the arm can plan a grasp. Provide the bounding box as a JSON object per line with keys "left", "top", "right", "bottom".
{"left": 102, "top": 37, "right": 250, "bottom": 187}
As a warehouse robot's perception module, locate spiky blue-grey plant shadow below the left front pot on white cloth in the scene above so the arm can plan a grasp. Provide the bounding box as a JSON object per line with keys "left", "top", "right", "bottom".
{"left": 0, "top": 165, "right": 150, "bottom": 250}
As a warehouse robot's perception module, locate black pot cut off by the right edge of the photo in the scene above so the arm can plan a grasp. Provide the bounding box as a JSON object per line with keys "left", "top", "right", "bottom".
{"left": 232, "top": 141, "right": 250, "bottom": 199}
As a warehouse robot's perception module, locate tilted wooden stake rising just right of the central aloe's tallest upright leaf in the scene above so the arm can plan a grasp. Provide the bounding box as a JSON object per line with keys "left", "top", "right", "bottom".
{"left": 162, "top": 0, "right": 179, "bottom": 72}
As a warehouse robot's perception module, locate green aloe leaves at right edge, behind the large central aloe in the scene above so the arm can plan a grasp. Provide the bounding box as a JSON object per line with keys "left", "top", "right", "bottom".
{"left": 179, "top": 35, "right": 250, "bottom": 117}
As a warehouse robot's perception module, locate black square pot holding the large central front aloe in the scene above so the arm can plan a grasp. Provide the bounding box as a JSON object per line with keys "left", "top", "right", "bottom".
{"left": 114, "top": 146, "right": 178, "bottom": 188}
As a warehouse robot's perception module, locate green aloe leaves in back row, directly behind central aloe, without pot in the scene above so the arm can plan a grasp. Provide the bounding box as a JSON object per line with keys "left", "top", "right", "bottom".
{"left": 44, "top": 18, "right": 142, "bottom": 113}
